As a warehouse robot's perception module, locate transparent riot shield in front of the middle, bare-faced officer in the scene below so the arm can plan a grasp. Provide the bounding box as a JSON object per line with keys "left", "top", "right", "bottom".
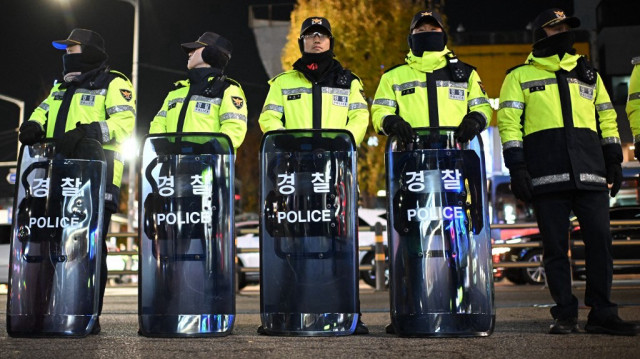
{"left": 260, "top": 130, "right": 358, "bottom": 336}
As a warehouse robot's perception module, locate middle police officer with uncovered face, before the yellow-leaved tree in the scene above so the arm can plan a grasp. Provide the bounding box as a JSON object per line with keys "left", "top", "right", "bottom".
{"left": 258, "top": 17, "right": 369, "bottom": 334}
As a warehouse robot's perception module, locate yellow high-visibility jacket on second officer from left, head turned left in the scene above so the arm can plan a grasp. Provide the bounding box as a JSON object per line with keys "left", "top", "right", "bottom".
{"left": 149, "top": 77, "right": 247, "bottom": 149}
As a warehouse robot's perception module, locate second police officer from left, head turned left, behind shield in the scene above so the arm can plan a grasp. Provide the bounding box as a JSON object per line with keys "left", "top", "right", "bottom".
{"left": 149, "top": 32, "right": 247, "bottom": 149}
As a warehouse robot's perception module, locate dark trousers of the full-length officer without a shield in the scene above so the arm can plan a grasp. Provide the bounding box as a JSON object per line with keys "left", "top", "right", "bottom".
{"left": 533, "top": 190, "right": 617, "bottom": 319}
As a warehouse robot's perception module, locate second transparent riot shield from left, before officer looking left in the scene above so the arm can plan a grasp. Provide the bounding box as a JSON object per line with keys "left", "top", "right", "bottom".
{"left": 138, "top": 133, "right": 235, "bottom": 337}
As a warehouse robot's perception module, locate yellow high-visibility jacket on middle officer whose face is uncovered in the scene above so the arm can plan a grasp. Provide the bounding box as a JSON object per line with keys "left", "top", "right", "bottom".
{"left": 258, "top": 62, "right": 369, "bottom": 144}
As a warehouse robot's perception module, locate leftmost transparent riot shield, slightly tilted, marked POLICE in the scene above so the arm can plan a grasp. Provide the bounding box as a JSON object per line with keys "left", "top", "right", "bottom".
{"left": 7, "top": 140, "right": 106, "bottom": 336}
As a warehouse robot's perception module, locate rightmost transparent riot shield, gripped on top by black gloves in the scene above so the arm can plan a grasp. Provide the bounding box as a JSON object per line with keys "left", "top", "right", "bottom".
{"left": 385, "top": 129, "right": 495, "bottom": 336}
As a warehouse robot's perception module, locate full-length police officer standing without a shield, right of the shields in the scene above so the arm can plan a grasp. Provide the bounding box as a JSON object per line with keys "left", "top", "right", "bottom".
{"left": 498, "top": 9, "right": 637, "bottom": 335}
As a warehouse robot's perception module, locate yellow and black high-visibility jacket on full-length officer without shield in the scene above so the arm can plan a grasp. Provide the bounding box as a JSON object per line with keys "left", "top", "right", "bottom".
{"left": 498, "top": 54, "right": 622, "bottom": 194}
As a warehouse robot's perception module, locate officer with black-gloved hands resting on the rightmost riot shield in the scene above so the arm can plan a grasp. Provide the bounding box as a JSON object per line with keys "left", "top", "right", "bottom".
{"left": 371, "top": 10, "right": 492, "bottom": 143}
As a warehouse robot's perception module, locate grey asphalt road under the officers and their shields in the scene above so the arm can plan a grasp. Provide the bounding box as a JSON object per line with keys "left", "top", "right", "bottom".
{"left": 0, "top": 280, "right": 640, "bottom": 359}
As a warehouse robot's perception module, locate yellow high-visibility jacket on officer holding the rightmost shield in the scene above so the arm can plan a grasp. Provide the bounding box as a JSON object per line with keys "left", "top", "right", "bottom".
{"left": 371, "top": 47, "right": 492, "bottom": 134}
